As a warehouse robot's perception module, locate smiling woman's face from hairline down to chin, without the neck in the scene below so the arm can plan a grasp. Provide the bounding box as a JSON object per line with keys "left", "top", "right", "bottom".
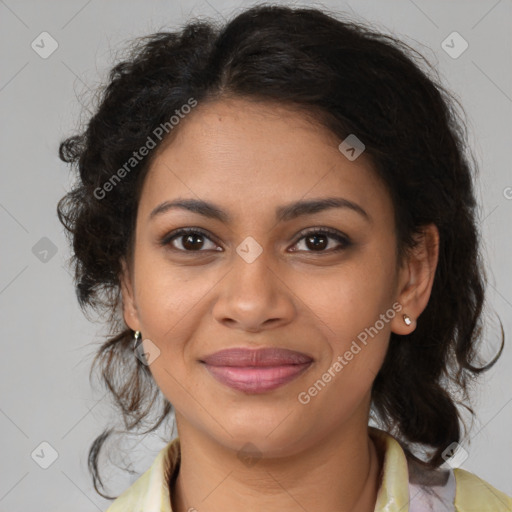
{"left": 122, "top": 99, "right": 436, "bottom": 456}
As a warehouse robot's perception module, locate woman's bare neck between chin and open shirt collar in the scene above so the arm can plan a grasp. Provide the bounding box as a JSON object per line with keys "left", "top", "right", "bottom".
{"left": 171, "top": 429, "right": 382, "bottom": 512}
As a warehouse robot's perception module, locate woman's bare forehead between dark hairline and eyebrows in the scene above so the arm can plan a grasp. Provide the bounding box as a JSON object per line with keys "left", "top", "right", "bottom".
{"left": 136, "top": 99, "right": 392, "bottom": 228}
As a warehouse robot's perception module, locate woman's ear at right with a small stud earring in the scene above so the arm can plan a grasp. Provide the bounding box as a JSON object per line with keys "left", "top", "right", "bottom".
{"left": 391, "top": 224, "right": 439, "bottom": 335}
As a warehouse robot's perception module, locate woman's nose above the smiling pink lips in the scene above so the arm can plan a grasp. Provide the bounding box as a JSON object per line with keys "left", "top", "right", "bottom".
{"left": 213, "top": 250, "right": 296, "bottom": 332}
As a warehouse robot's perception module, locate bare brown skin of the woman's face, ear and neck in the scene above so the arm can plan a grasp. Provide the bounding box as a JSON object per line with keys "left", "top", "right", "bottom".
{"left": 121, "top": 99, "right": 439, "bottom": 512}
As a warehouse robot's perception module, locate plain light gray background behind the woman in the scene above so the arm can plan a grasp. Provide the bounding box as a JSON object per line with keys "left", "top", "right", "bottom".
{"left": 0, "top": 0, "right": 512, "bottom": 512}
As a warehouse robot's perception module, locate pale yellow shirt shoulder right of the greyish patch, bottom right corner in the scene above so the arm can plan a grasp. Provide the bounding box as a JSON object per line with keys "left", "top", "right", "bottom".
{"left": 453, "top": 468, "right": 512, "bottom": 512}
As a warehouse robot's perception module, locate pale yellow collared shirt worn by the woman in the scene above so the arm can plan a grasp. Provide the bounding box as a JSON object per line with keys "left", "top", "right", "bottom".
{"left": 105, "top": 427, "right": 512, "bottom": 512}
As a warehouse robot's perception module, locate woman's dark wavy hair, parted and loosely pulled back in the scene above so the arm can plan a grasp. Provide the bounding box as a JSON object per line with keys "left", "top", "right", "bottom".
{"left": 57, "top": 4, "right": 504, "bottom": 499}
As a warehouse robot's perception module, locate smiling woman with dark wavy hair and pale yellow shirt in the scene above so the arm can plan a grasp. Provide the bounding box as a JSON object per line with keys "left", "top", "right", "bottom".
{"left": 58, "top": 5, "right": 512, "bottom": 512}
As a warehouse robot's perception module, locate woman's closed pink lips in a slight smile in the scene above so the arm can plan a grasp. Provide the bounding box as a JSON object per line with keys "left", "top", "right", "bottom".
{"left": 201, "top": 348, "right": 313, "bottom": 393}
